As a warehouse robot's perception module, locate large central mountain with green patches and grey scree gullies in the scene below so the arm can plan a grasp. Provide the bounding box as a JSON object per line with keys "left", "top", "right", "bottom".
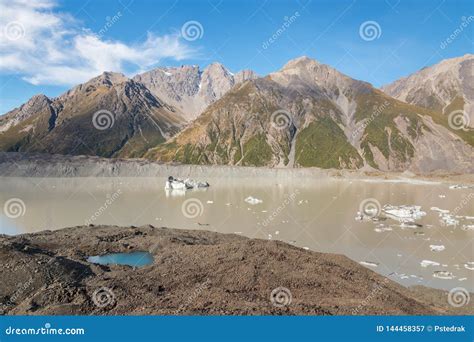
{"left": 145, "top": 57, "right": 474, "bottom": 171}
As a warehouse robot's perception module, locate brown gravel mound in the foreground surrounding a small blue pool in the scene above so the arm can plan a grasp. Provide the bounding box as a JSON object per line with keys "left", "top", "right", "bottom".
{"left": 0, "top": 226, "right": 474, "bottom": 315}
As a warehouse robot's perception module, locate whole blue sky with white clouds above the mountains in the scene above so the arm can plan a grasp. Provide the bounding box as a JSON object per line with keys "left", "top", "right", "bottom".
{"left": 0, "top": 0, "right": 474, "bottom": 113}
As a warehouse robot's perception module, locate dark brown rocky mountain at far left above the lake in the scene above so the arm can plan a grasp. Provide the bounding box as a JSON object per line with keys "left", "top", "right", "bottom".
{"left": 0, "top": 72, "right": 185, "bottom": 157}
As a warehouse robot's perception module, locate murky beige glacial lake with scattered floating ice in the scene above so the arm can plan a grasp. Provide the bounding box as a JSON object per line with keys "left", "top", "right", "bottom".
{"left": 0, "top": 177, "right": 474, "bottom": 291}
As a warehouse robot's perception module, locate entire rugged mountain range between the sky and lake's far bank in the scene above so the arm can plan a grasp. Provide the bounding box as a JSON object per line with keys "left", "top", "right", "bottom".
{"left": 0, "top": 55, "right": 474, "bottom": 172}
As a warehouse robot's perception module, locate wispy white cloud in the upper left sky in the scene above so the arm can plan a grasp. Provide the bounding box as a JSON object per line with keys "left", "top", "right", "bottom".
{"left": 0, "top": 0, "right": 195, "bottom": 85}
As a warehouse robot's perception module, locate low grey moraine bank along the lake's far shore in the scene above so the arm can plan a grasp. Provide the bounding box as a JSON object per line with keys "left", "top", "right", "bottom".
{"left": 0, "top": 152, "right": 474, "bottom": 184}
